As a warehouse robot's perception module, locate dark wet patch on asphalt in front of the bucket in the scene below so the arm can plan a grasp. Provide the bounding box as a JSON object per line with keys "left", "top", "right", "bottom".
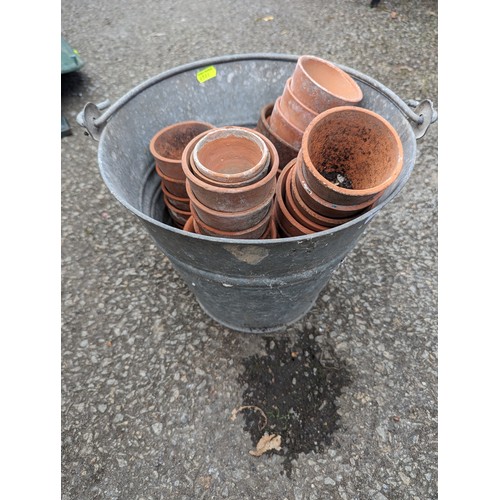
{"left": 233, "top": 330, "right": 351, "bottom": 477}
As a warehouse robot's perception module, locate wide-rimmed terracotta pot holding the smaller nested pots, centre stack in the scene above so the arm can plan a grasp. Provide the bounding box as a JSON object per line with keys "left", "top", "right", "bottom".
{"left": 182, "top": 128, "right": 279, "bottom": 212}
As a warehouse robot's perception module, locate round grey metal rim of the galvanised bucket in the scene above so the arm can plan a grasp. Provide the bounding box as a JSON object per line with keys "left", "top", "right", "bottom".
{"left": 97, "top": 53, "right": 417, "bottom": 246}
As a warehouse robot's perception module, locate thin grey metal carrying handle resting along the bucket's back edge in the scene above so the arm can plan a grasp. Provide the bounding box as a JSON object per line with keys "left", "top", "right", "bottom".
{"left": 76, "top": 54, "right": 437, "bottom": 141}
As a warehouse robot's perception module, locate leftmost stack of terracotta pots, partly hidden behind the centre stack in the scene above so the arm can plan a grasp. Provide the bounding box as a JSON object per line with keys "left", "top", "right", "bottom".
{"left": 149, "top": 121, "right": 214, "bottom": 228}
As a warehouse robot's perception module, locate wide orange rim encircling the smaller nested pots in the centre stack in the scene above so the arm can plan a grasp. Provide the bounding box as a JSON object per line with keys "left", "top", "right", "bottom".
{"left": 182, "top": 127, "right": 279, "bottom": 195}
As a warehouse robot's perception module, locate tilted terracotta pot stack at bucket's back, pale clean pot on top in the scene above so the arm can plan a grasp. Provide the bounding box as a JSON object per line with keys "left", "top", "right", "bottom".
{"left": 257, "top": 55, "right": 363, "bottom": 169}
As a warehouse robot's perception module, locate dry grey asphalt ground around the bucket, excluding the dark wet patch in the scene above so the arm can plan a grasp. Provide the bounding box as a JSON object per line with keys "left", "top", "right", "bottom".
{"left": 61, "top": 0, "right": 438, "bottom": 500}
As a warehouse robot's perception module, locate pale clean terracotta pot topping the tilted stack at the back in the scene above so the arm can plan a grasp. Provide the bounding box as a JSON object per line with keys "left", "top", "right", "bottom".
{"left": 290, "top": 55, "right": 363, "bottom": 113}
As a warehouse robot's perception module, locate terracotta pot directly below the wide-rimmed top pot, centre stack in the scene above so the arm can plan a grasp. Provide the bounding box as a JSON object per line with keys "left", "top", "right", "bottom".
{"left": 187, "top": 185, "right": 274, "bottom": 231}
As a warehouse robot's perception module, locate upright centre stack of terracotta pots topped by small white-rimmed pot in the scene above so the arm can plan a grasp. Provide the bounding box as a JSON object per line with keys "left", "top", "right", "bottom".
{"left": 182, "top": 127, "right": 279, "bottom": 239}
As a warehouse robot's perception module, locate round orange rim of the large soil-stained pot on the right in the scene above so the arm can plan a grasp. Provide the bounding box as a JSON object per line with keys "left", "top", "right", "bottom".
{"left": 301, "top": 106, "right": 404, "bottom": 197}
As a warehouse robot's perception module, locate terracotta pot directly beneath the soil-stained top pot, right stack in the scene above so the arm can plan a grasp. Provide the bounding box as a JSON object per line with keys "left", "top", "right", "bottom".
{"left": 294, "top": 153, "right": 382, "bottom": 219}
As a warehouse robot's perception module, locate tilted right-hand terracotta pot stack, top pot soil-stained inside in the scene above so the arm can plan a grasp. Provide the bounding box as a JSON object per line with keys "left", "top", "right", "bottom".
{"left": 276, "top": 106, "right": 403, "bottom": 237}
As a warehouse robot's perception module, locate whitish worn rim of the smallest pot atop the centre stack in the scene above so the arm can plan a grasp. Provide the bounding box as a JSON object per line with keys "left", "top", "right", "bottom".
{"left": 191, "top": 126, "right": 271, "bottom": 184}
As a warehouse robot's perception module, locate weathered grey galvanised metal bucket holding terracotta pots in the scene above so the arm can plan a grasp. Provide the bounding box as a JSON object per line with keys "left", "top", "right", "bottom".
{"left": 79, "top": 54, "right": 436, "bottom": 333}
